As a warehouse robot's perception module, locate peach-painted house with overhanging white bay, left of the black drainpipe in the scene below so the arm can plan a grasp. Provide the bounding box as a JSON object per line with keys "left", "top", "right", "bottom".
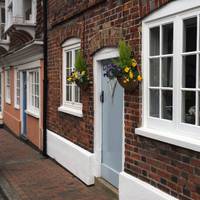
{"left": 0, "top": 0, "right": 43, "bottom": 149}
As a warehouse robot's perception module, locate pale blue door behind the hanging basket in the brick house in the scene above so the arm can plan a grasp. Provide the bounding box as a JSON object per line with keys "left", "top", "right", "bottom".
{"left": 101, "top": 60, "right": 124, "bottom": 188}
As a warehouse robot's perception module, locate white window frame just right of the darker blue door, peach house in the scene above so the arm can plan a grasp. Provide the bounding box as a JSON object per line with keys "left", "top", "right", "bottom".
{"left": 26, "top": 68, "right": 40, "bottom": 118}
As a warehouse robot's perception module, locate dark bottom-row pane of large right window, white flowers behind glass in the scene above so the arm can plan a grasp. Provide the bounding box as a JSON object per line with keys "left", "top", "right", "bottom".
{"left": 182, "top": 91, "right": 196, "bottom": 124}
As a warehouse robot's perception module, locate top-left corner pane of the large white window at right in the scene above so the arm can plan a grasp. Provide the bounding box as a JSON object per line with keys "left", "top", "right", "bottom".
{"left": 150, "top": 27, "right": 160, "bottom": 56}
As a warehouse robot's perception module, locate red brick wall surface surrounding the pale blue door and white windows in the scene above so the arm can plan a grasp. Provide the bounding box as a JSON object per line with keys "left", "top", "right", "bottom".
{"left": 47, "top": 0, "right": 200, "bottom": 200}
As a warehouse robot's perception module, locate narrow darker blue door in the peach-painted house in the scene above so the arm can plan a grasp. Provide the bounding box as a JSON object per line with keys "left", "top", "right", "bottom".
{"left": 22, "top": 72, "right": 27, "bottom": 137}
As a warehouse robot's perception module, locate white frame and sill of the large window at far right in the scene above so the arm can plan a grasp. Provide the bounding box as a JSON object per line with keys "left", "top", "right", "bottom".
{"left": 136, "top": 0, "right": 200, "bottom": 151}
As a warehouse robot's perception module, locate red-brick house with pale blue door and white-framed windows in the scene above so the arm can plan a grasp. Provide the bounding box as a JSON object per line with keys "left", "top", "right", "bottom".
{"left": 47, "top": 0, "right": 200, "bottom": 200}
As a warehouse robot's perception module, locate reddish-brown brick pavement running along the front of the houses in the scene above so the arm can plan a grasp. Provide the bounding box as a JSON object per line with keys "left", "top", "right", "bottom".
{"left": 0, "top": 129, "right": 117, "bottom": 200}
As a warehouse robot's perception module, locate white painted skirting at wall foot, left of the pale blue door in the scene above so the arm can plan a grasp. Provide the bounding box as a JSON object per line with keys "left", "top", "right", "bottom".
{"left": 47, "top": 130, "right": 94, "bottom": 185}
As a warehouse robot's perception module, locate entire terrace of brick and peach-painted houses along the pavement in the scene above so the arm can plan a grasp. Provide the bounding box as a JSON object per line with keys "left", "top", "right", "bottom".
{"left": 0, "top": 0, "right": 200, "bottom": 200}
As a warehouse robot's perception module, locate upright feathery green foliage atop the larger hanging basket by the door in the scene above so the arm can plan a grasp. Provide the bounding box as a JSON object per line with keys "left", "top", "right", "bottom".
{"left": 115, "top": 40, "right": 132, "bottom": 68}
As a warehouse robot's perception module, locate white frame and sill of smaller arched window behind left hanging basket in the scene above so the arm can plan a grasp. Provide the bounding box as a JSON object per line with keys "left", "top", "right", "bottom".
{"left": 58, "top": 38, "right": 83, "bottom": 117}
